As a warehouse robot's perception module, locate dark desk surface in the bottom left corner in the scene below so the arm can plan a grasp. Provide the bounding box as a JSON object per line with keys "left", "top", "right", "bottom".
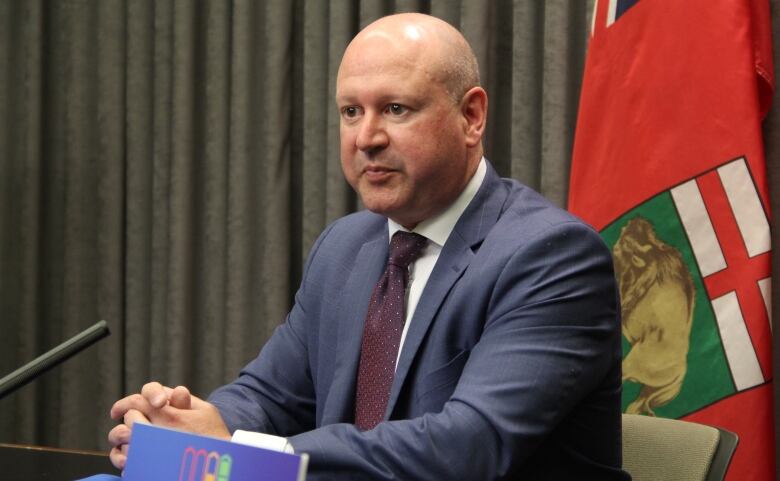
{"left": 0, "top": 444, "right": 119, "bottom": 481}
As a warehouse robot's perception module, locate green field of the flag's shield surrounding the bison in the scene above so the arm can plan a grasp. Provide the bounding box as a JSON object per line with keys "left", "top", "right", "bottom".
{"left": 601, "top": 187, "right": 736, "bottom": 418}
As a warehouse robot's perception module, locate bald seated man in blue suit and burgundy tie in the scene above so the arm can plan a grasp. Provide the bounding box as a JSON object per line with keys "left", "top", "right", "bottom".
{"left": 109, "top": 14, "right": 628, "bottom": 481}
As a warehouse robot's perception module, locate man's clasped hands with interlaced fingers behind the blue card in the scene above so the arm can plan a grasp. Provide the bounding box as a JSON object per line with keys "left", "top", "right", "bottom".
{"left": 108, "top": 382, "right": 230, "bottom": 469}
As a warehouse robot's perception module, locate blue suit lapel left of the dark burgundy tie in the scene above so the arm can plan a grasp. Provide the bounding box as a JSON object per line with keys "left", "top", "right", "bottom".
{"left": 321, "top": 232, "right": 389, "bottom": 425}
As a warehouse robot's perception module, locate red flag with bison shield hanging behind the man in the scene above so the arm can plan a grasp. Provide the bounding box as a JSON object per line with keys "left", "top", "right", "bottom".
{"left": 569, "top": 0, "right": 775, "bottom": 481}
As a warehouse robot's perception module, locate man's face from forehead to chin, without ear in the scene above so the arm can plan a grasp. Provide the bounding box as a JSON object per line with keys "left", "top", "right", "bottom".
{"left": 336, "top": 36, "right": 471, "bottom": 228}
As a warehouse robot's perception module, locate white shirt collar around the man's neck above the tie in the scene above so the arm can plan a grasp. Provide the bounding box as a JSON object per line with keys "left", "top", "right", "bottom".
{"left": 387, "top": 157, "right": 487, "bottom": 247}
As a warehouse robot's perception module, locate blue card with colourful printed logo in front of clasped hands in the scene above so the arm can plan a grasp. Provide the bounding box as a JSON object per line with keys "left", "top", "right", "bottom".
{"left": 122, "top": 423, "right": 308, "bottom": 481}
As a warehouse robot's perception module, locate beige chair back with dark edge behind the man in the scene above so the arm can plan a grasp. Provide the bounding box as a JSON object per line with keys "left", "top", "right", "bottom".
{"left": 623, "top": 414, "right": 738, "bottom": 481}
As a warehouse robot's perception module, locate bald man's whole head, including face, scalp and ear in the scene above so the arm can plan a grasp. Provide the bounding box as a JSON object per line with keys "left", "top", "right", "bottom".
{"left": 336, "top": 14, "right": 487, "bottom": 229}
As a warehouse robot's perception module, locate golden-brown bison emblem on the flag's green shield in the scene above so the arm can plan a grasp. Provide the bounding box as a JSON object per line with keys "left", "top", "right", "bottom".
{"left": 612, "top": 217, "right": 695, "bottom": 415}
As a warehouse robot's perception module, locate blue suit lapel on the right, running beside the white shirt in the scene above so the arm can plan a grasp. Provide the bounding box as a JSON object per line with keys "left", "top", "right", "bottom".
{"left": 382, "top": 163, "right": 508, "bottom": 419}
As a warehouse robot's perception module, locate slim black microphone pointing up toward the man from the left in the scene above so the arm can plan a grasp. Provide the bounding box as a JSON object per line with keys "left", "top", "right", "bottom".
{"left": 0, "top": 321, "right": 111, "bottom": 399}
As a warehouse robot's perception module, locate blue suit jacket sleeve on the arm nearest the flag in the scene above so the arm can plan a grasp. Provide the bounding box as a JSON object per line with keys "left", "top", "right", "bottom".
{"left": 290, "top": 222, "right": 620, "bottom": 481}
